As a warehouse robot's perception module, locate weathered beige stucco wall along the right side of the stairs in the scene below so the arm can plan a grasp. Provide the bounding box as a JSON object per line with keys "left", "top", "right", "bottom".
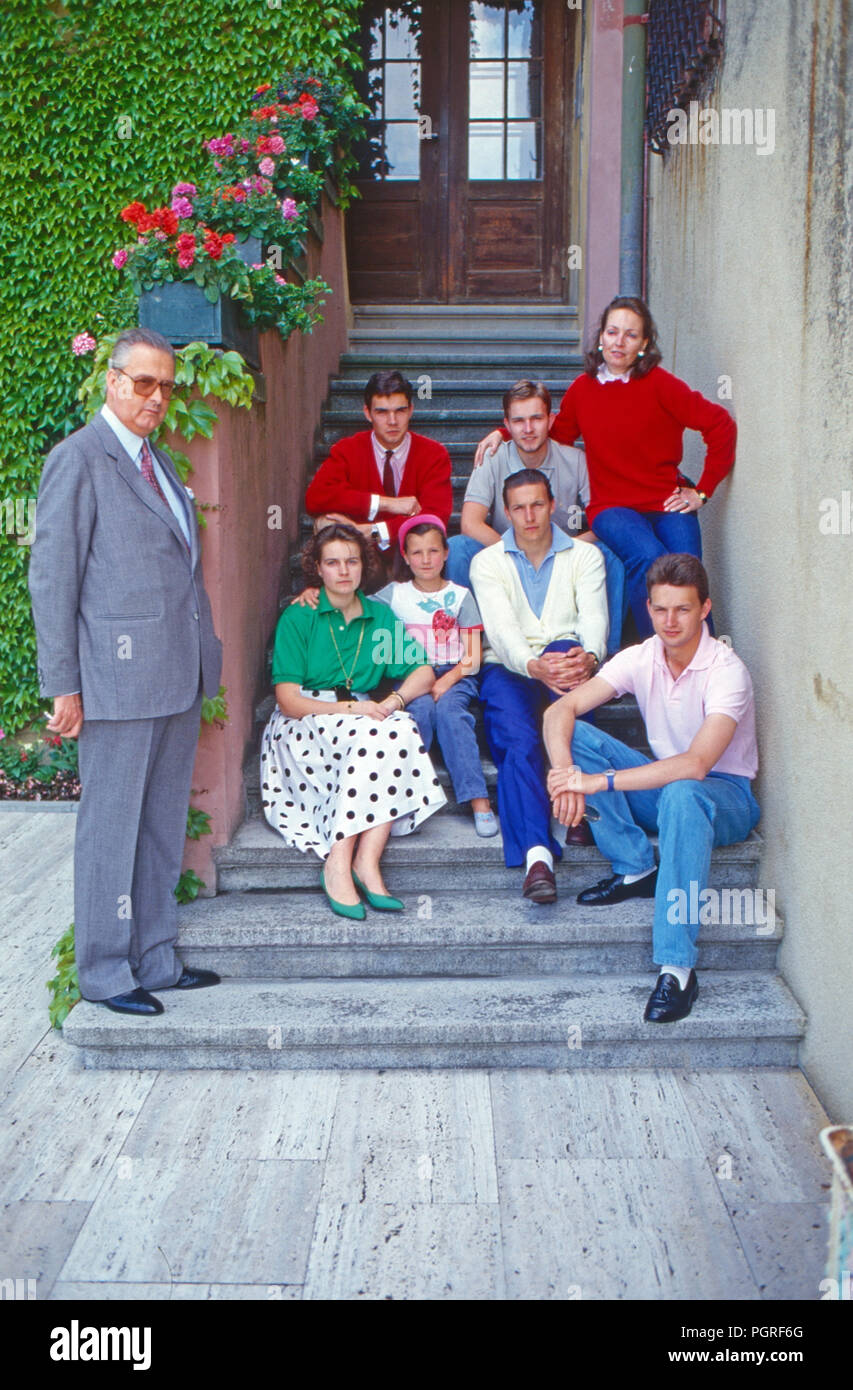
{"left": 649, "top": 0, "right": 853, "bottom": 1120}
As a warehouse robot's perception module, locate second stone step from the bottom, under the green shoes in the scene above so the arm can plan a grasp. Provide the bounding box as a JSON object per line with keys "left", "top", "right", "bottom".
{"left": 178, "top": 884, "right": 782, "bottom": 979}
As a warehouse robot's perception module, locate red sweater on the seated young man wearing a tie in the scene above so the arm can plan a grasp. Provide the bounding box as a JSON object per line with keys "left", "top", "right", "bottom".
{"left": 306, "top": 430, "right": 453, "bottom": 541}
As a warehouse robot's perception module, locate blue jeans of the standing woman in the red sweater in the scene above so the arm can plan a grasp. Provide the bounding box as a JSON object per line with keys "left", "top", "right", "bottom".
{"left": 593, "top": 507, "right": 714, "bottom": 636}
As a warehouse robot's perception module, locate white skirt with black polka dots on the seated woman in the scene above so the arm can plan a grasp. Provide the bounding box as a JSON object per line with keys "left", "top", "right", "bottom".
{"left": 261, "top": 709, "right": 446, "bottom": 859}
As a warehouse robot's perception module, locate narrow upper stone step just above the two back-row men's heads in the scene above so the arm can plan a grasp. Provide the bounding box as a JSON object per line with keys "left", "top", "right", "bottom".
{"left": 338, "top": 353, "right": 583, "bottom": 380}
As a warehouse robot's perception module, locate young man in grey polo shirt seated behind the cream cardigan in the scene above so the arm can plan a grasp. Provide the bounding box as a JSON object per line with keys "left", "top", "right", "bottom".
{"left": 445, "top": 381, "right": 625, "bottom": 656}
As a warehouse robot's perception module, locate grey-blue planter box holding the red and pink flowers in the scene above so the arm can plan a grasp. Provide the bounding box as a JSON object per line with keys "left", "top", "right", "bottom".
{"left": 139, "top": 236, "right": 261, "bottom": 368}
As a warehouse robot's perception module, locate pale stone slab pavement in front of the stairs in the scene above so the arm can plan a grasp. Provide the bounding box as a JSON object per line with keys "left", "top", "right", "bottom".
{"left": 0, "top": 810, "right": 829, "bottom": 1301}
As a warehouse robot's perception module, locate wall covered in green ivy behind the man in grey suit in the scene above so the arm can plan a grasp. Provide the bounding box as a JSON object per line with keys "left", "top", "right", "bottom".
{"left": 0, "top": 0, "right": 358, "bottom": 733}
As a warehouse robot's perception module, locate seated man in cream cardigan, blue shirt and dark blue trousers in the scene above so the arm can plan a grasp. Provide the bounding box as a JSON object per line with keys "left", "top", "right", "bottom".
{"left": 471, "top": 468, "right": 607, "bottom": 902}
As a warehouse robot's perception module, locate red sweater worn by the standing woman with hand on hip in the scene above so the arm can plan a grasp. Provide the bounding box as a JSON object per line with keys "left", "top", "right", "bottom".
{"left": 504, "top": 367, "right": 738, "bottom": 524}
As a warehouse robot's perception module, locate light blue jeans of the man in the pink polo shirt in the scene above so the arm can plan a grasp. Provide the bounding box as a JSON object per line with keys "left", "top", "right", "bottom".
{"left": 571, "top": 721, "right": 760, "bottom": 969}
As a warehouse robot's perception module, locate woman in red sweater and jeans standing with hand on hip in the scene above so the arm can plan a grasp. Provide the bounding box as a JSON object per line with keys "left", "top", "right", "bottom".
{"left": 474, "top": 295, "right": 738, "bottom": 639}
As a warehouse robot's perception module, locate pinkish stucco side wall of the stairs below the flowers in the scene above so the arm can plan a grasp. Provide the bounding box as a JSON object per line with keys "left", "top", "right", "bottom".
{"left": 183, "top": 197, "right": 350, "bottom": 892}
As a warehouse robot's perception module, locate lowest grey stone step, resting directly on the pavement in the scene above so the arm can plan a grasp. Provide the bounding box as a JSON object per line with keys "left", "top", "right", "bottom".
{"left": 63, "top": 970, "right": 804, "bottom": 1070}
